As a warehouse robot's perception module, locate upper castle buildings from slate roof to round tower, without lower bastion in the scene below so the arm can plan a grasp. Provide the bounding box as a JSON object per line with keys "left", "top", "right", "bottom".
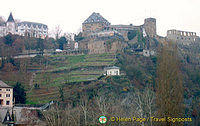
{"left": 82, "top": 12, "right": 157, "bottom": 40}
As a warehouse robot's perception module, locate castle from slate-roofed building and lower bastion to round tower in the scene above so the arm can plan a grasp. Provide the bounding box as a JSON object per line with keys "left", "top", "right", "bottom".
{"left": 79, "top": 12, "right": 157, "bottom": 53}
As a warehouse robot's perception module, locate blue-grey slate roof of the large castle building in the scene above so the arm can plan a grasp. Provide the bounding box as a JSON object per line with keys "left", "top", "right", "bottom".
{"left": 83, "top": 12, "right": 110, "bottom": 25}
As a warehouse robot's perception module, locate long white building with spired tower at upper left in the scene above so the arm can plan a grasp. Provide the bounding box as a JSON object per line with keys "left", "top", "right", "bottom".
{"left": 0, "top": 13, "right": 48, "bottom": 38}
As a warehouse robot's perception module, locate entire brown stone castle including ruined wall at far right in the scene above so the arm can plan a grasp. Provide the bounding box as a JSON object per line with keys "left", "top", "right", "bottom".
{"left": 79, "top": 12, "right": 200, "bottom": 53}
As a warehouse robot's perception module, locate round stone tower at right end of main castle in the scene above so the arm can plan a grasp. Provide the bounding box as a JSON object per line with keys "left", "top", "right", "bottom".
{"left": 143, "top": 18, "right": 157, "bottom": 37}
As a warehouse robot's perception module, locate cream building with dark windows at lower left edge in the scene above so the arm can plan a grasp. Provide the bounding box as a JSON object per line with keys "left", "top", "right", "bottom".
{"left": 0, "top": 80, "right": 13, "bottom": 107}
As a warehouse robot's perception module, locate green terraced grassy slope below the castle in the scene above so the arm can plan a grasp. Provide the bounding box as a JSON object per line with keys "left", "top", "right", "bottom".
{"left": 27, "top": 53, "right": 115, "bottom": 104}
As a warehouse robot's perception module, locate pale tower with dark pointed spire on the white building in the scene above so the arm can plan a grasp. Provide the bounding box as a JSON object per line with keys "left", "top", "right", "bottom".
{"left": 6, "top": 13, "right": 16, "bottom": 34}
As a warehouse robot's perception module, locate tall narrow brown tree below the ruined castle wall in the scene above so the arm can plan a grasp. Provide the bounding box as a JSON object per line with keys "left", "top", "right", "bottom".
{"left": 156, "top": 43, "right": 184, "bottom": 125}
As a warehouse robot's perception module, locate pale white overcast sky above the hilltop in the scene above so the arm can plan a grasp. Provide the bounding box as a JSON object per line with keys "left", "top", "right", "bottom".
{"left": 0, "top": 0, "right": 200, "bottom": 36}
